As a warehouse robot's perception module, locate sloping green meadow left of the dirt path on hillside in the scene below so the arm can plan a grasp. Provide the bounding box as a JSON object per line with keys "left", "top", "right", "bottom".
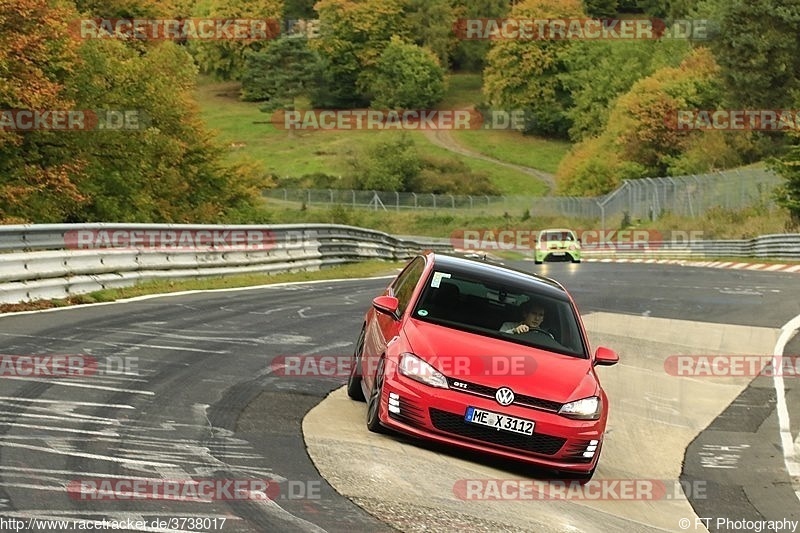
{"left": 196, "top": 74, "right": 546, "bottom": 192}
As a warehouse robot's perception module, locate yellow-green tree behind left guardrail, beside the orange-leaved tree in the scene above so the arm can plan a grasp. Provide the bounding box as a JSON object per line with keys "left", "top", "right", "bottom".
{"left": 61, "top": 40, "right": 266, "bottom": 223}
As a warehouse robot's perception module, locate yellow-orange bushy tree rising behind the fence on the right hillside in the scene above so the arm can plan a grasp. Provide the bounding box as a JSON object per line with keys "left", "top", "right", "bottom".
{"left": 557, "top": 48, "right": 739, "bottom": 195}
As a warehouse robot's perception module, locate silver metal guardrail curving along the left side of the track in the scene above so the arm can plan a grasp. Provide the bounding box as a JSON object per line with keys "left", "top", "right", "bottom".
{"left": 0, "top": 223, "right": 452, "bottom": 303}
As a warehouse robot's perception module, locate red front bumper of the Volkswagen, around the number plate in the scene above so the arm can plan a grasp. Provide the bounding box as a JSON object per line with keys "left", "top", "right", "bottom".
{"left": 379, "top": 374, "right": 605, "bottom": 473}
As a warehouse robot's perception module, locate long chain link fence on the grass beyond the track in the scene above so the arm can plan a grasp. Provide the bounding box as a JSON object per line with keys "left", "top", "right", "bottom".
{"left": 263, "top": 169, "right": 782, "bottom": 224}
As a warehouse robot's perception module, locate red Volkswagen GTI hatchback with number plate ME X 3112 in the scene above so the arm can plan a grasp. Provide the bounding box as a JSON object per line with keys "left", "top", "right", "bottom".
{"left": 347, "top": 253, "right": 619, "bottom": 480}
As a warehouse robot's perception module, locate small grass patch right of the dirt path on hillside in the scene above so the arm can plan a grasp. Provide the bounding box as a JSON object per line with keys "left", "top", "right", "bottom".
{"left": 453, "top": 130, "right": 571, "bottom": 174}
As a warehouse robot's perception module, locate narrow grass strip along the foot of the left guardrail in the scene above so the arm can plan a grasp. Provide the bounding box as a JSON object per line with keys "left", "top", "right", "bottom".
{"left": 0, "top": 260, "right": 405, "bottom": 313}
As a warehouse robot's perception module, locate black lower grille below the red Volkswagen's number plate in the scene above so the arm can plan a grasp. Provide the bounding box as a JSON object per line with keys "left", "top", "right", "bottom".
{"left": 430, "top": 408, "right": 567, "bottom": 455}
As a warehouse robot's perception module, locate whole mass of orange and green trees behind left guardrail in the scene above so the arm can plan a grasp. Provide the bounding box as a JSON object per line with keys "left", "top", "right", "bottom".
{"left": 0, "top": 0, "right": 268, "bottom": 223}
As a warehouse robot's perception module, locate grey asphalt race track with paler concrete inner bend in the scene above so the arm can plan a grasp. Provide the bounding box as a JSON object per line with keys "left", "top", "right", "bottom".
{"left": 0, "top": 263, "right": 800, "bottom": 532}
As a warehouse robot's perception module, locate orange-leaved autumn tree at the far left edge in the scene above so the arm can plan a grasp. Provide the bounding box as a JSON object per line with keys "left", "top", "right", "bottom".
{"left": 0, "top": 0, "right": 84, "bottom": 223}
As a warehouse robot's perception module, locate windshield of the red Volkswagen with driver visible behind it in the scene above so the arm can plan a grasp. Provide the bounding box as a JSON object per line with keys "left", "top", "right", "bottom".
{"left": 412, "top": 270, "right": 588, "bottom": 358}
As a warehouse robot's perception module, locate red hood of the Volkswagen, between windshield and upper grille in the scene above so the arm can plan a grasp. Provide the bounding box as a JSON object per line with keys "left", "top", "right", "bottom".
{"left": 403, "top": 319, "right": 599, "bottom": 403}
